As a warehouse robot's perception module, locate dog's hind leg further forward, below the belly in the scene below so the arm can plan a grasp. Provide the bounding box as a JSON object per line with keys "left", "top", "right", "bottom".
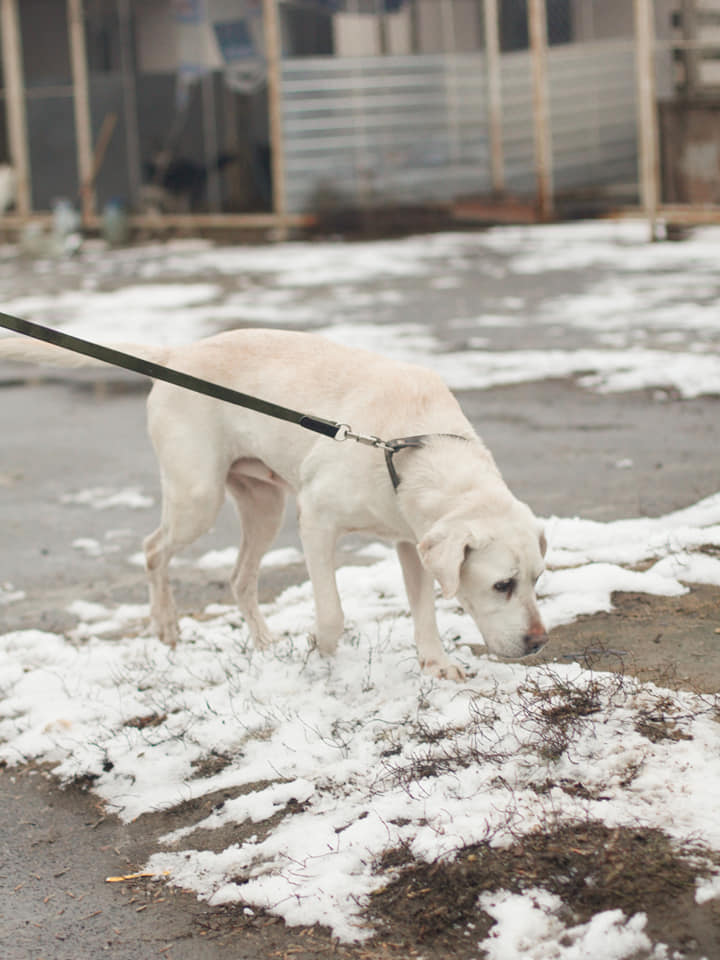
{"left": 227, "top": 461, "right": 286, "bottom": 649}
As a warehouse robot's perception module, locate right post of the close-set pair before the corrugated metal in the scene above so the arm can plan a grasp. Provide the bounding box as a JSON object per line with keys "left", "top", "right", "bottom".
{"left": 527, "top": 0, "right": 554, "bottom": 220}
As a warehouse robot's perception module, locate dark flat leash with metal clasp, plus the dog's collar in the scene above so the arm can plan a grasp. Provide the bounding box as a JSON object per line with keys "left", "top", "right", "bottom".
{"left": 0, "top": 311, "right": 438, "bottom": 490}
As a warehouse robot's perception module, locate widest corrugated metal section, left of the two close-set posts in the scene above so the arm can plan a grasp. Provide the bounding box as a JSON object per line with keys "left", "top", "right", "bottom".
{"left": 283, "top": 54, "right": 496, "bottom": 211}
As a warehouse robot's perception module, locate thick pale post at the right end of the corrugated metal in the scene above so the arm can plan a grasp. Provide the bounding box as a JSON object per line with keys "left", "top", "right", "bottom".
{"left": 635, "top": 0, "right": 660, "bottom": 240}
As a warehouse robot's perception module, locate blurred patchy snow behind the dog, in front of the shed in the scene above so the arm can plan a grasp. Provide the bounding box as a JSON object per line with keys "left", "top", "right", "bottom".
{"left": 0, "top": 221, "right": 720, "bottom": 397}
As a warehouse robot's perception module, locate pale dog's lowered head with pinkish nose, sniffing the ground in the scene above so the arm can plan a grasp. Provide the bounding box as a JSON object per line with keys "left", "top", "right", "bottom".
{"left": 418, "top": 499, "right": 547, "bottom": 657}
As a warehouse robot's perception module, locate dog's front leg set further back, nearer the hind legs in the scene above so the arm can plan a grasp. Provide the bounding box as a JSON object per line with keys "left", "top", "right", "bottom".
{"left": 300, "top": 504, "right": 345, "bottom": 656}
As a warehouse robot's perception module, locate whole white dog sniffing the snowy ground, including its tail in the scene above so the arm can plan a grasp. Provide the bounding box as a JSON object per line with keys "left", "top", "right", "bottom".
{"left": 0, "top": 330, "right": 547, "bottom": 680}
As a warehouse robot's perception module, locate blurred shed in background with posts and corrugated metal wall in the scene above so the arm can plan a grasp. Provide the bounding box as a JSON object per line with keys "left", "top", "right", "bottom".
{"left": 0, "top": 0, "right": 708, "bottom": 233}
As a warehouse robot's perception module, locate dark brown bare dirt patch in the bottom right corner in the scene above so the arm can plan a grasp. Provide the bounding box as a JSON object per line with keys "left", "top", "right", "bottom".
{"left": 368, "top": 822, "right": 720, "bottom": 958}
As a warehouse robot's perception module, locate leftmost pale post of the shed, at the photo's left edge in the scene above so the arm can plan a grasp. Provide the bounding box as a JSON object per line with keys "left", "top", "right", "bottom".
{"left": 0, "top": 0, "right": 32, "bottom": 217}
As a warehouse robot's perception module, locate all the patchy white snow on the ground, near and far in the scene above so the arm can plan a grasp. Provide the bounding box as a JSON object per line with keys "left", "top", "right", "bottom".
{"left": 0, "top": 223, "right": 720, "bottom": 960}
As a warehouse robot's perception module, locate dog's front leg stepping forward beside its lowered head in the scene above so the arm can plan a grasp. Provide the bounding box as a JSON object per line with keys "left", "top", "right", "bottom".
{"left": 396, "top": 541, "right": 465, "bottom": 681}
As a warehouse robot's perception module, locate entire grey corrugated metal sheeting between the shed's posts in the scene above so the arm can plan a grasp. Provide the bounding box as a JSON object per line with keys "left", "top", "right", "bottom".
{"left": 282, "top": 40, "right": 637, "bottom": 212}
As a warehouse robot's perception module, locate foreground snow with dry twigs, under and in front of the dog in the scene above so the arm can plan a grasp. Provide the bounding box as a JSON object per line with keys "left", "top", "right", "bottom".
{"left": 0, "top": 494, "right": 720, "bottom": 960}
